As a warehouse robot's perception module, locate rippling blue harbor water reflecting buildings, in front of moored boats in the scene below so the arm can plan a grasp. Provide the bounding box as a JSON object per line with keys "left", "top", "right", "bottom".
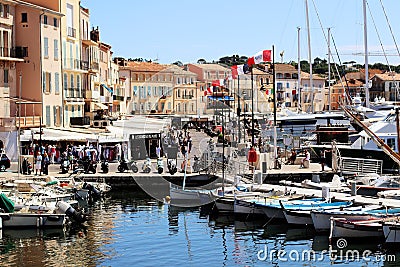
{"left": 0, "top": 191, "right": 400, "bottom": 266}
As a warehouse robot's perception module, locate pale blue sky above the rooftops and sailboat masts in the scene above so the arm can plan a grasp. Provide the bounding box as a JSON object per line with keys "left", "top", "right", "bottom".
{"left": 81, "top": 0, "right": 400, "bottom": 65}
